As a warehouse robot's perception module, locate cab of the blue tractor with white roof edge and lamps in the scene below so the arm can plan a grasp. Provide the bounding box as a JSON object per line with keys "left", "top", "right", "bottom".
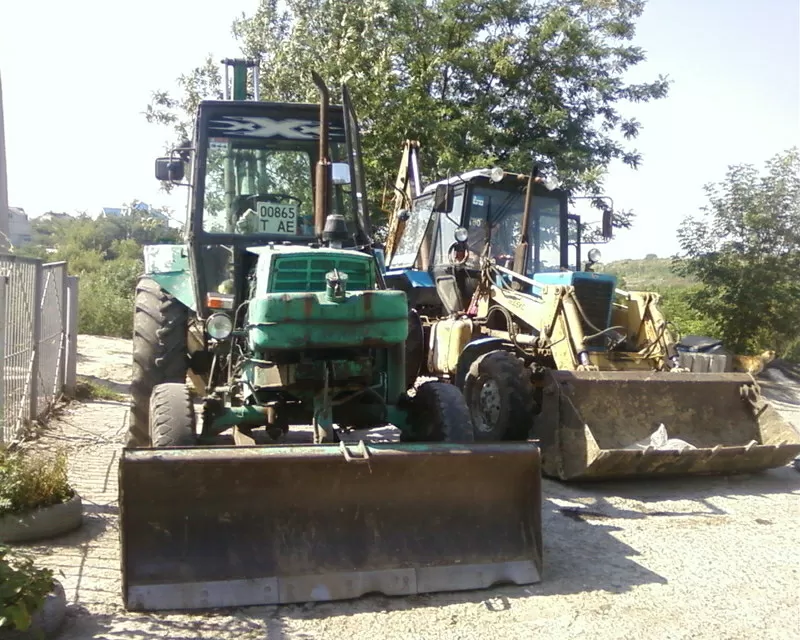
{"left": 385, "top": 168, "right": 608, "bottom": 314}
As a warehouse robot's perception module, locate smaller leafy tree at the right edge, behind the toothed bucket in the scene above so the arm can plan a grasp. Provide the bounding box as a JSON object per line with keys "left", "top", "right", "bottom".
{"left": 676, "top": 147, "right": 800, "bottom": 353}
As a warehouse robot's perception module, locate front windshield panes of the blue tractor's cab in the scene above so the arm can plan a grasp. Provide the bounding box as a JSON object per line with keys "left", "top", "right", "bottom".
{"left": 467, "top": 185, "right": 561, "bottom": 273}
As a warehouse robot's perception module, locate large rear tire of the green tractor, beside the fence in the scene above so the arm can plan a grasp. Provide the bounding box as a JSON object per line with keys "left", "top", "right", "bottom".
{"left": 127, "top": 277, "right": 189, "bottom": 447}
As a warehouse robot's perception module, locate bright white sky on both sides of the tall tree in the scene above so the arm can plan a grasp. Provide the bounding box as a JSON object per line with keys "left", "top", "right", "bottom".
{"left": 0, "top": 0, "right": 800, "bottom": 260}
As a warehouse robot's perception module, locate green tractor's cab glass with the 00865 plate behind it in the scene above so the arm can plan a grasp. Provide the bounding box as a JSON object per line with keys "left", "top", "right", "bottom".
{"left": 203, "top": 136, "right": 355, "bottom": 239}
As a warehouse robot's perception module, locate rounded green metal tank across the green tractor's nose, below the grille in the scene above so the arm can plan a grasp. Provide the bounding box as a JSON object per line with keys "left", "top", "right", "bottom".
{"left": 247, "top": 290, "right": 408, "bottom": 351}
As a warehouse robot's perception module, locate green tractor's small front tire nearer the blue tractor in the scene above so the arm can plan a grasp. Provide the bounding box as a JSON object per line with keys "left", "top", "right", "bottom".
{"left": 405, "top": 382, "right": 475, "bottom": 443}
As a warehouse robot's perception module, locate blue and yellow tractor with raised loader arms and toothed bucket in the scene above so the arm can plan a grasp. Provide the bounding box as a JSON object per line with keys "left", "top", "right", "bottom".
{"left": 384, "top": 141, "right": 800, "bottom": 480}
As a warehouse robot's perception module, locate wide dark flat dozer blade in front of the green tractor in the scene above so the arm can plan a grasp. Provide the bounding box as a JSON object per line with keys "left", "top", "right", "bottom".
{"left": 119, "top": 442, "right": 542, "bottom": 611}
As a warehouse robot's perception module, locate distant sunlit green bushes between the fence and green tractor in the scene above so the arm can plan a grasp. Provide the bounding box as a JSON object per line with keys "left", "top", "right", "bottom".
{"left": 18, "top": 201, "right": 180, "bottom": 338}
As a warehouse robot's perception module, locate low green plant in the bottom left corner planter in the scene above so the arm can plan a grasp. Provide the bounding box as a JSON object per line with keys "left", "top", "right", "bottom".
{"left": 0, "top": 545, "right": 53, "bottom": 631}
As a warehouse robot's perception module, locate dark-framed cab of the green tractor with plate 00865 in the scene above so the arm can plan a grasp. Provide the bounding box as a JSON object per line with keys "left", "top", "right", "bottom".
{"left": 148, "top": 60, "right": 376, "bottom": 318}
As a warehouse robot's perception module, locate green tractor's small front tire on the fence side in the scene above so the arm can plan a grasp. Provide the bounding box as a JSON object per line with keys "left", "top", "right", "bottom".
{"left": 150, "top": 382, "right": 197, "bottom": 447}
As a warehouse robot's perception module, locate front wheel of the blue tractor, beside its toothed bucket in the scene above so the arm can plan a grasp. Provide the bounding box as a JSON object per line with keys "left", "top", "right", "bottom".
{"left": 464, "top": 351, "right": 536, "bottom": 442}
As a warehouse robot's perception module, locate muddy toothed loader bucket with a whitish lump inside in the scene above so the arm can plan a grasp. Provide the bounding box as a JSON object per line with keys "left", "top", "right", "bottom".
{"left": 534, "top": 371, "right": 800, "bottom": 480}
